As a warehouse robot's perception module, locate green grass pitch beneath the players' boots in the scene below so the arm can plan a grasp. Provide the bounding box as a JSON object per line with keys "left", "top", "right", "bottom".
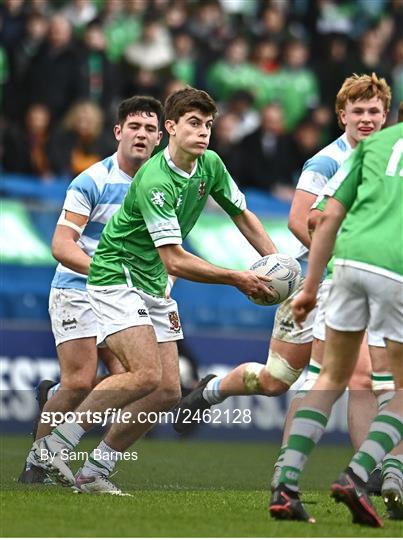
{"left": 0, "top": 436, "right": 402, "bottom": 537}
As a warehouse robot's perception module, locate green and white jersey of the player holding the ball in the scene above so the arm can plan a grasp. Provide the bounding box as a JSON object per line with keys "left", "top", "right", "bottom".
{"left": 87, "top": 148, "right": 246, "bottom": 297}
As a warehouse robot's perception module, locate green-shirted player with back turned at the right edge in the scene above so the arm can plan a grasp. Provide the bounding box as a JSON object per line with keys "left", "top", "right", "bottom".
{"left": 270, "top": 123, "right": 403, "bottom": 527}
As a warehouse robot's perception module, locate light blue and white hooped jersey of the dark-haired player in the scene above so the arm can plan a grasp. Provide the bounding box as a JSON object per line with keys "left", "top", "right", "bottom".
{"left": 51, "top": 153, "right": 132, "bottom": 291}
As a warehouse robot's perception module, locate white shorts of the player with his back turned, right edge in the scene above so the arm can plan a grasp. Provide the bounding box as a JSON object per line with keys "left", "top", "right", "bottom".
{"left": 326, "top": 263, "right": 403, "bottom": 347}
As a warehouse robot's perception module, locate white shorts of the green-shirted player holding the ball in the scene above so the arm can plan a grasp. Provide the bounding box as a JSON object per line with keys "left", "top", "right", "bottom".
{"left": 87, "top": 285, "right": 183, "bottom": 345}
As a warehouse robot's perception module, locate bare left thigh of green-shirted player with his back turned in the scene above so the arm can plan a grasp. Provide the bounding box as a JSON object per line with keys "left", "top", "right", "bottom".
{"left": 321, "top": 328, "right": 364, "bottom": 386}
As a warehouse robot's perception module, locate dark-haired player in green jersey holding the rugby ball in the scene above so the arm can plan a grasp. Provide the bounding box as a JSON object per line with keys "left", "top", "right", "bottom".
{"left": 30, "top": 87, "right": 276, "bottom": 491}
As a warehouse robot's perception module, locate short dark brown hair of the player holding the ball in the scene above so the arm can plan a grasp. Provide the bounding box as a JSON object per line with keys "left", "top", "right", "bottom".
{"left": 164, "top": 86, "right": 217, "bottom": 122}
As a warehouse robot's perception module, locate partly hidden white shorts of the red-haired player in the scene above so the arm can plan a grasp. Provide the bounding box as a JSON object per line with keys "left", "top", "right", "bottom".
{"left": 272, "top": 278, "right": 322, "bottom": 345}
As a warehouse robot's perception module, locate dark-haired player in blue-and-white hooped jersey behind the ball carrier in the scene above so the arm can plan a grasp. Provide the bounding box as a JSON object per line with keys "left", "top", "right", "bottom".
{"left": 19, "top": 96, "right": 162, "bottom": 489}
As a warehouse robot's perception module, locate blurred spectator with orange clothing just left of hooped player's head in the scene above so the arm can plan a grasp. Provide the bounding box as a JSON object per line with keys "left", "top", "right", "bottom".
{"left": 49, "top": 101, "right": 115, "bottom": 177}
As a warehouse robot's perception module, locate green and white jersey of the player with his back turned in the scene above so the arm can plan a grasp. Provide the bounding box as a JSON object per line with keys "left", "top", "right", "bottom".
{"left": 323, "top": 123, "right": 403, "bottom": 282}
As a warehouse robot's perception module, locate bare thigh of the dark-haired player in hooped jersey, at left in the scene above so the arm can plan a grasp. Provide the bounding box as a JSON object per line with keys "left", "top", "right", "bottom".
{"left": 57, "top": 337, "right": 98, "bottom": 389}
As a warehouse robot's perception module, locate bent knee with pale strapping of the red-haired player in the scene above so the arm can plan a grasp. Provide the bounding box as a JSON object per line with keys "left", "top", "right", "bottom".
{"left": 262, "top": 349, "right": 303, "bottom": 396}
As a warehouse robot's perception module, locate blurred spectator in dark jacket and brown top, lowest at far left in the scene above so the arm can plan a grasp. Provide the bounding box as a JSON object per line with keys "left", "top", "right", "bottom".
{"left": 3, "top": 103, "right": 53, "bottom": 180}
